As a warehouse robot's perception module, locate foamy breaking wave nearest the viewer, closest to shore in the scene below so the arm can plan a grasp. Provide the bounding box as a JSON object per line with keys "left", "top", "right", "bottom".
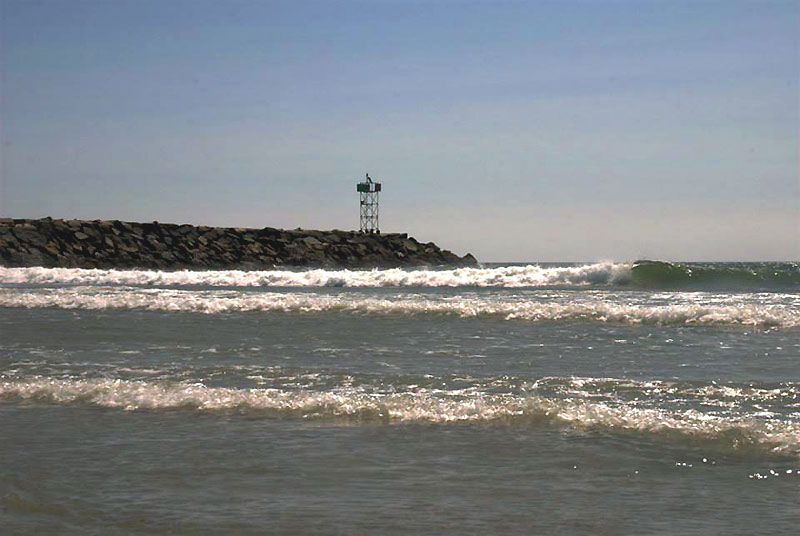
{"left": 0, "top": 377, "right": 800, "bottom": 458}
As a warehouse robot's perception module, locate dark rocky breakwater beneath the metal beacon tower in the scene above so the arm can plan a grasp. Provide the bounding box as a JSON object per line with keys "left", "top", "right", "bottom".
{"left": 0, "top": 218, "right": 477, "bottom": 270}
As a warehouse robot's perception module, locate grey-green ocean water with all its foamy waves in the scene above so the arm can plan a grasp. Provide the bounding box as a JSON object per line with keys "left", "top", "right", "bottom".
{"left": 0, "top": 263, "right": 800, "bottom": 535}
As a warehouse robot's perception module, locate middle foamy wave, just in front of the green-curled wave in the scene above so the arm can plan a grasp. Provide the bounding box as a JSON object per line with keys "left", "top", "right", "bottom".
{"left": 0, "top": 287, "right": 800, "bottom": 327}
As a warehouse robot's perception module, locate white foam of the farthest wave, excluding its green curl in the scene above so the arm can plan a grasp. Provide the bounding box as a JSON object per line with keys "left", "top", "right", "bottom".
{"left": 0, "top": 262, "right": 631, "bottom": 287}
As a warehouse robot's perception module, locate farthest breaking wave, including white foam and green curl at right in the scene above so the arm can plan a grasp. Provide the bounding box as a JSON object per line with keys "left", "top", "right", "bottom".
{"left": 0, "top": 261, "right": 800, "bottom": 288}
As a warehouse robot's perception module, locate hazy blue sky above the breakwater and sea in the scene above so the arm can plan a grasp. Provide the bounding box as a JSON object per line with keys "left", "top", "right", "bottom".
{"left": 0, "top": 0, "right": 800, "bottom": 262}
